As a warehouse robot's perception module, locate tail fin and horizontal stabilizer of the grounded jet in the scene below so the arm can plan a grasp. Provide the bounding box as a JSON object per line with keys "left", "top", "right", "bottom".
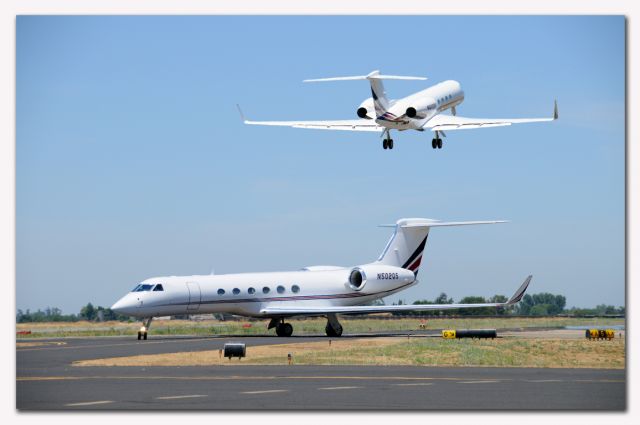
{"left": 378, "top": 218, "right": 505, "bottom": 276}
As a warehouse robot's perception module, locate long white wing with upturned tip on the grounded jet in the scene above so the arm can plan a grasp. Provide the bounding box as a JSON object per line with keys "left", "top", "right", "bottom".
{"left": 260, "top": 275, "right": 533, "bottom": 316}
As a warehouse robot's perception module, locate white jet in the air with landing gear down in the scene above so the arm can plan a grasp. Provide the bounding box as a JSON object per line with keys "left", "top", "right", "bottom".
{"left": 238, "top": 71, "right": 558, "bottom": 149}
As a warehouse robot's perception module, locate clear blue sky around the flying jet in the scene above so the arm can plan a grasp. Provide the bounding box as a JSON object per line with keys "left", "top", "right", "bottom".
{"left": 16, "top": 16, "right": 625, "bottom": 313}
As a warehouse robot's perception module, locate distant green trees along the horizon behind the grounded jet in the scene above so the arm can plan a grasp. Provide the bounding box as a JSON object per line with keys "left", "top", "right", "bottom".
{"left": 16, "top": 292, "right": 626, "bottom": 323}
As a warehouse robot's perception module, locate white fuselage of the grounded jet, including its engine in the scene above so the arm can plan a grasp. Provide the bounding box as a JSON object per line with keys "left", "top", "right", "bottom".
{"left": 112, "top": 263, "right": 417, "bottom": 317}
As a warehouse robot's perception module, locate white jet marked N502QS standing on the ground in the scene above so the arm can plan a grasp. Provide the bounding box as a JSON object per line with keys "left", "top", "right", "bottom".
{"left": 111, "top": 218, "right": 531, "bottom": 339}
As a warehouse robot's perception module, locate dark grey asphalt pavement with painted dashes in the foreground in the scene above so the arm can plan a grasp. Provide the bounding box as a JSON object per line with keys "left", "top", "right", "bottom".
{"left": 16, "top": 335, "right": 626, "bottom": 410}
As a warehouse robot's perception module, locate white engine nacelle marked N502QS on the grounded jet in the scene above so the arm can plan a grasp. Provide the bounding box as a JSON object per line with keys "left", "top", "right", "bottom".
{"left": 348, "top": 264, "right": 416, "bottom": 292}
